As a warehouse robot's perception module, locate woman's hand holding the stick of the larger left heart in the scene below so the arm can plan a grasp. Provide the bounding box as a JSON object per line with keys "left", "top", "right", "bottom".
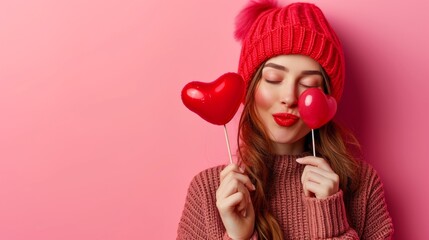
{"left": 216, "top": 164, "right": 255, "bottom": 239}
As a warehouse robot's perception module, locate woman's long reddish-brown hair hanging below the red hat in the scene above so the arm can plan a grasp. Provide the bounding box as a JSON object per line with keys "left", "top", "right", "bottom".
{"left": 237, "top": 62, "right": 359, "bottom": 240}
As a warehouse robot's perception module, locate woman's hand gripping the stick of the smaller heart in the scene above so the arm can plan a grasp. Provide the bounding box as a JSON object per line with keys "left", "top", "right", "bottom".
{"left": 296, "top": 156, "right": 340, "bottom": 199}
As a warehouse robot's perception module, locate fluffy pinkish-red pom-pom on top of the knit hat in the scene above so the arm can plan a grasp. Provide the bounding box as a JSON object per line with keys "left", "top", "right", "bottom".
{"left": 234, "top": 0, "right": 278, "bottom": 41}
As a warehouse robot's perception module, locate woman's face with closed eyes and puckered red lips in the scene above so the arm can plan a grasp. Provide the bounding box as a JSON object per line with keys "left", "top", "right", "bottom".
{"left": 255, "top": 55, "right": 323, "bottom": 154}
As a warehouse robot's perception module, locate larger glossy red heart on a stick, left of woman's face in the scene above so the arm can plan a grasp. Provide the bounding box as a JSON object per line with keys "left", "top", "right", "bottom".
{"left": 182, "top": 73, "right": 244, "bottom": 125}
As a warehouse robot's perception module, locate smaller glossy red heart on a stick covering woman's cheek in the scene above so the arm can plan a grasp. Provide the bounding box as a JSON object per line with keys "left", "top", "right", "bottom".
{"left": 298, "top": 88, "right": 337, "bottom": 129}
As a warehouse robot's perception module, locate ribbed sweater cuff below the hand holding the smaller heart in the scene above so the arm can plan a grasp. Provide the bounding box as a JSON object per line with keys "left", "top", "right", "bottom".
{"left": 303, "top": 190, "right": 350, "bottom": 239}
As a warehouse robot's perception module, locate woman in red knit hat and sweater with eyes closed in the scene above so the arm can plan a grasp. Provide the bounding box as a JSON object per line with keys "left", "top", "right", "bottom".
{"left": 177, "top": 1, "right": 393, "bottom": 240}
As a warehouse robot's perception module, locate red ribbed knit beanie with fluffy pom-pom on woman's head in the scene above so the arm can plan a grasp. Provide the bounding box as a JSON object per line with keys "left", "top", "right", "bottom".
{"left": 235, "top": 0, "right": 345, "bottom": 101}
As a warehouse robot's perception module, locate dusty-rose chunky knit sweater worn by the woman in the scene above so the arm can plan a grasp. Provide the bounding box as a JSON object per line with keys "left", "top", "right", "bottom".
{"left": 177, "top": 156, "right": 393, "bottom": 239}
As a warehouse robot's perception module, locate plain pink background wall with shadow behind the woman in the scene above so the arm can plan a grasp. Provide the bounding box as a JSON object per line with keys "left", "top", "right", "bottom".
{"left": 0, "top": 0, "right": 429, "bottom": 240}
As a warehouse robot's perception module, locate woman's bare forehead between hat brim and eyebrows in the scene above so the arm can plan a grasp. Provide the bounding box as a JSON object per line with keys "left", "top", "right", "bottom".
{"left": 265, "top": 54, "right": 321, "bottom": 71}
